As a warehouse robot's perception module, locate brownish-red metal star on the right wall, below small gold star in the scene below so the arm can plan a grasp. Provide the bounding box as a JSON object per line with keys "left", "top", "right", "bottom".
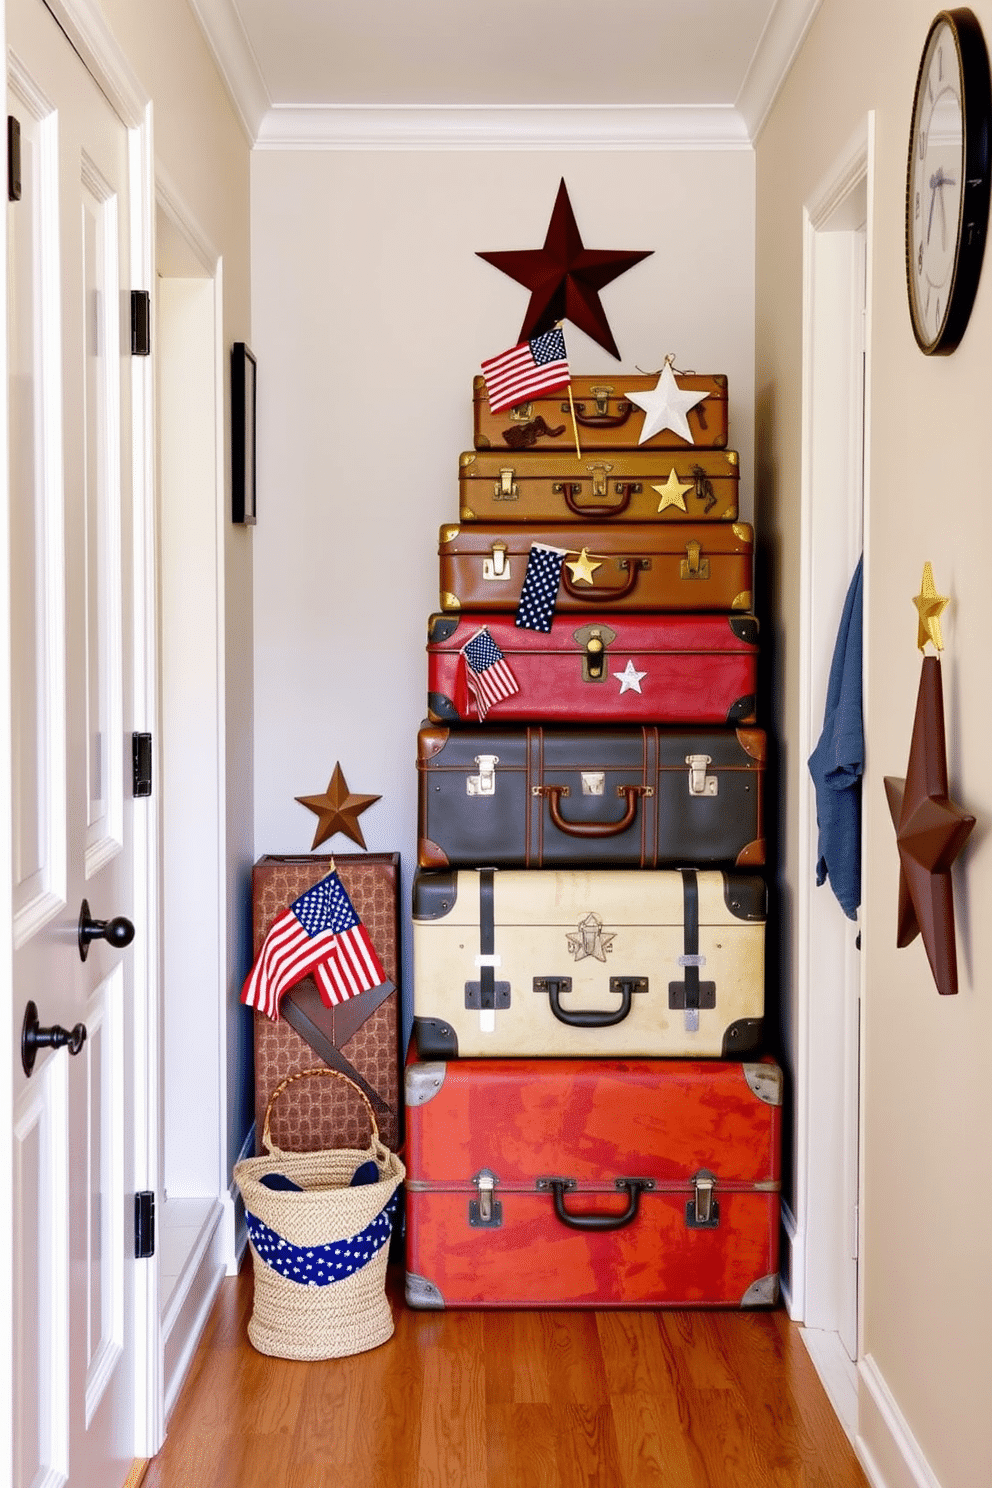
{"left": 885, "top": 656, "right": 974, "bottom": 995}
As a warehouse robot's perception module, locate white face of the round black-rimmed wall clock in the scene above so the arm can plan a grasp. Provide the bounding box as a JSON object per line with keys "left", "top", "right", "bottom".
{"left": 906, "top": 21, "right": 965, "bottom": 351}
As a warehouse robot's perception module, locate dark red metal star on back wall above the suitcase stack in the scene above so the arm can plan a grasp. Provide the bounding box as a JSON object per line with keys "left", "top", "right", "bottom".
{"left": 479, "top": 179, "right": 654, "bottom": 360}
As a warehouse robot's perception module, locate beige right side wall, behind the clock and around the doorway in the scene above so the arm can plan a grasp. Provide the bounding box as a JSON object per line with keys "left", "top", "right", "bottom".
{"left": 756, "top": 0, "right": 992, "bottom": 1488}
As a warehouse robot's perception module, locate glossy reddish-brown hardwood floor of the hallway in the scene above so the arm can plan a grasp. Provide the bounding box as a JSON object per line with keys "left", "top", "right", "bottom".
{"left": 143, "top": 1263, "right": 867, "bottom": 1488}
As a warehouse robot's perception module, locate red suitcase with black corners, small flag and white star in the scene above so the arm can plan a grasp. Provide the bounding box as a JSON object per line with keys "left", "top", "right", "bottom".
{"left": 427, "top": 613, "right": 759, "bottom": 725}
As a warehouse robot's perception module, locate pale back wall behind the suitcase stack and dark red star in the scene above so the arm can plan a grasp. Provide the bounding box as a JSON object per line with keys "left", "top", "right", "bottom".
{"left": 251, "top": 152, "right": 754, "bottom": 1035}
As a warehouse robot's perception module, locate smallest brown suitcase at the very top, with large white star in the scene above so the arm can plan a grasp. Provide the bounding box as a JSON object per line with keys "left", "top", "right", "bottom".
{"left": 471, "top": 372, "right": 727, "bottom": 454}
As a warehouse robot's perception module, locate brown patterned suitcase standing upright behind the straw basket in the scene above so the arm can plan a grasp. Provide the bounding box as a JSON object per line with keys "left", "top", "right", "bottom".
{"left": 251, "top": 853, "right": 402, "bottom": 1152}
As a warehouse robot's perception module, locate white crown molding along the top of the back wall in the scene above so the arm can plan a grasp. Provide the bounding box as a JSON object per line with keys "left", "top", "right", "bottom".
{"left": 256, "top": 104, "right": 751, "bottom": 150}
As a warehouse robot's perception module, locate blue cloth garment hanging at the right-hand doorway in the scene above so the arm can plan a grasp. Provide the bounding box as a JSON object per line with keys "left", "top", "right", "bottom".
{"left": 809, "top": 557, "right": 864, "bottom": 920}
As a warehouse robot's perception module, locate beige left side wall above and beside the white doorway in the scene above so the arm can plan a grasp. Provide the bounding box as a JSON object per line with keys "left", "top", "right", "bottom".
{"left": 100, "top": 0, "right": 254, "bottom": 1161}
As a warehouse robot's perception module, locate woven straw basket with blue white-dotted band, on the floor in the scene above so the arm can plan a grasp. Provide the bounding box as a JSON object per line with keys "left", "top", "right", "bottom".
{"left": 233, "top": 1068, "right": 406, "bottom": 1359}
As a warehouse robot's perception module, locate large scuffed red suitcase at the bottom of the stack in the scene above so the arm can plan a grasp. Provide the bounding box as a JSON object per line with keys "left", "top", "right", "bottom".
{"left": 405, "top": 1059, "right": 782, "bottom": 1308}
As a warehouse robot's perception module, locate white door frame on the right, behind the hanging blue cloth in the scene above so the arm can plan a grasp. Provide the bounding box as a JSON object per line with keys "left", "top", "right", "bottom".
{"left": 788, "top": 113, "right": 875, "bottom": 1382}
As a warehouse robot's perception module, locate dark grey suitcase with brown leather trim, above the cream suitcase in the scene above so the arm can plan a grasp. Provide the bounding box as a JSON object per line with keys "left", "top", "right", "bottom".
{"left": 416, "top": 722, "right": 767, "bottom": 869}
